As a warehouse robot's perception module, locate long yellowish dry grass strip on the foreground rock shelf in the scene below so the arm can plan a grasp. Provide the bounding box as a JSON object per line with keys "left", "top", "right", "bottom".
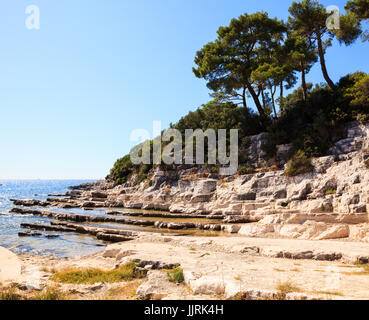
{"left": 51, "top": 262, "right": 146, "bottom": 284}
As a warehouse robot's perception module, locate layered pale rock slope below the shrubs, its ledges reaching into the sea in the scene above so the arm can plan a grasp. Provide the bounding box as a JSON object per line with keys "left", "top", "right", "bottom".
{"left": 9, "top": 122, "right": 369, "bottom": 242}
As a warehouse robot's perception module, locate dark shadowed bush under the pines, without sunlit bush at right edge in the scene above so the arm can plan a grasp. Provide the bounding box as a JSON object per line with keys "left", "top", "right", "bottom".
{"left": 264, "top": 81, "right": 355, "bottom": 157}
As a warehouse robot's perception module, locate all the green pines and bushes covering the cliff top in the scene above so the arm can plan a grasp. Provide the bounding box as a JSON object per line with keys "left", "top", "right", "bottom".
{"left": 107, "top": 0, "right": 369, "bottom": 184}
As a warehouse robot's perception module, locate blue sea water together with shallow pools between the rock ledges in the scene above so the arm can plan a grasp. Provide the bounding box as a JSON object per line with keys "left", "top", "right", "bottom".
{"left": 0, "top": 180, "right": 230, "bottom": 257}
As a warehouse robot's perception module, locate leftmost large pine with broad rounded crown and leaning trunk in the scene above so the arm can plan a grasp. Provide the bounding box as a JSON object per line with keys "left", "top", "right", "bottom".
{"left": 193, "top": 12, "right": 287, "bottom": 116}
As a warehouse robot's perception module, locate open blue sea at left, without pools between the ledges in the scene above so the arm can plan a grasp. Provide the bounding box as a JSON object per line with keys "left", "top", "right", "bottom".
{"left": 0, "top": 180, "right": 106, "bottom": 257}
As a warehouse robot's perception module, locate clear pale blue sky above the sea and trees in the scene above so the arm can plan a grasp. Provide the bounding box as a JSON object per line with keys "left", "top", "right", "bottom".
{"left": 0, "top": 0, "right": 369, "bottom": 179}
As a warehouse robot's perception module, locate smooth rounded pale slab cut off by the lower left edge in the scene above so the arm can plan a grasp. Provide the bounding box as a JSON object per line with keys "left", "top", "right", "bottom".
{"left": 0, "top": 247, "right": 22, "bottom": 283}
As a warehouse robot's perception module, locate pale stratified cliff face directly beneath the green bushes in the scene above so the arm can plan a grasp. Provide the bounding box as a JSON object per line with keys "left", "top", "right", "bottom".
{"left": 84, "top": 122, "right": 369, "bottom": 241}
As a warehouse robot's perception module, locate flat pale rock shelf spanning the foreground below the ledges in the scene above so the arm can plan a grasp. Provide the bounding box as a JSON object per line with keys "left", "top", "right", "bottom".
{"left": 3, "top": 233, "right": 369, "bottom": 300}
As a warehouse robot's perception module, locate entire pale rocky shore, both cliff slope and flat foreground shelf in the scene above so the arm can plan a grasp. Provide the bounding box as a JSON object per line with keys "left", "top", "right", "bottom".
{"left": 5, "top": 122, "right": 369, "bottom": 300}
